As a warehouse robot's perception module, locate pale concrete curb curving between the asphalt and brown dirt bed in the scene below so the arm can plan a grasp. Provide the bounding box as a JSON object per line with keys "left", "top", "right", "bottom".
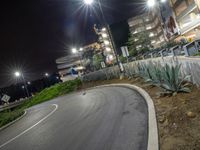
{"left": 89, "top": 84, "right": 159, "bottom": 150}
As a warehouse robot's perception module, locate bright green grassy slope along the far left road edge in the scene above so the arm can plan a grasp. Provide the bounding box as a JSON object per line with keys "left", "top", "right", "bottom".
{"left": 0, "top": 79, "right": 81, "bottom": 127}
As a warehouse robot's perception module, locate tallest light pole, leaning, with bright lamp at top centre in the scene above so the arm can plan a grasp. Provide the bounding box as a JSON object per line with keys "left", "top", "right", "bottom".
{"left": 83, "top": 0, "right": 123, "bottom": 73}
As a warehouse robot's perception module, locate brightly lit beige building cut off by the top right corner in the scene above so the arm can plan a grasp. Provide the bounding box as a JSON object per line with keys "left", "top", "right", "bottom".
{"left": 169, "top": 0, "right": 200, "bottom": 41}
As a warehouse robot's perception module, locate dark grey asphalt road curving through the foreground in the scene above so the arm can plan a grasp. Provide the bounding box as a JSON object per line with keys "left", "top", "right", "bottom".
{"left": 0, "top": 87, "right": 148, "bottom": 150}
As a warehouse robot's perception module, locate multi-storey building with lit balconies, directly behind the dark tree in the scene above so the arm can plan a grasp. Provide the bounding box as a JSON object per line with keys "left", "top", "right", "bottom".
{"left": 128, "top": 11, "right": 166, "bottom": 49}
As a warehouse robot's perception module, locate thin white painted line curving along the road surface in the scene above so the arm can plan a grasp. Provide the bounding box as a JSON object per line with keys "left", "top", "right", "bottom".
{"left": 0, "top": 104, "right": 58, "bottom": 148}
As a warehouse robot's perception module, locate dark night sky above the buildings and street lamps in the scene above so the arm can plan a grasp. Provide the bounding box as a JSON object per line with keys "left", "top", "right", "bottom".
{"left": 0, "top": 0, "right": 142, "bottom": 86}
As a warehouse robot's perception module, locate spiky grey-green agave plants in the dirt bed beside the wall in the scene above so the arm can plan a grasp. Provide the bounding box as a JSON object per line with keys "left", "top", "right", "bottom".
{"left": 134, "top": 63, "right": 190, "bottom": 93}
